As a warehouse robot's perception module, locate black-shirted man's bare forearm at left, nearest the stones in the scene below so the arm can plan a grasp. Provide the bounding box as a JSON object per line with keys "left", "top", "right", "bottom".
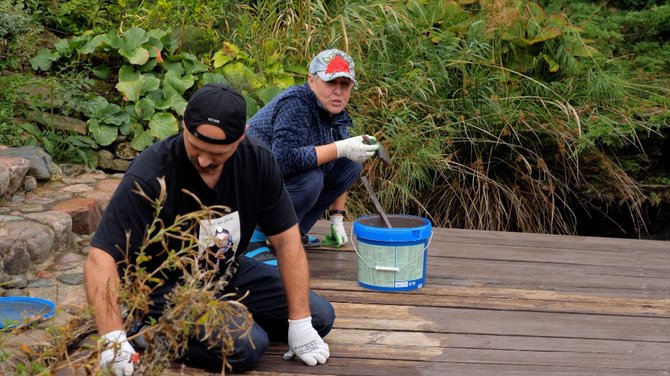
{"left": 84, "top": 248, "right": 123, "bottom": 335}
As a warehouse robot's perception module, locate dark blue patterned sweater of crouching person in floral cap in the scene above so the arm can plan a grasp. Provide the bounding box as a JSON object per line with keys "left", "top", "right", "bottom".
{"left": 247, "top": 84, "right": 353, "bottom": 178}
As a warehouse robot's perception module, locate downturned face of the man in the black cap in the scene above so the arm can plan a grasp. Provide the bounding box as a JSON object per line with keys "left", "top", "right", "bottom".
{"left": 184, "top": 124, "right": 244, "bottom": 174}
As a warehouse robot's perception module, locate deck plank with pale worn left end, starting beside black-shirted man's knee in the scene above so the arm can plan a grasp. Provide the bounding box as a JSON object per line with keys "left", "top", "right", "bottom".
{"left": 326, "top": 303, "right": 670, "bottom": 342}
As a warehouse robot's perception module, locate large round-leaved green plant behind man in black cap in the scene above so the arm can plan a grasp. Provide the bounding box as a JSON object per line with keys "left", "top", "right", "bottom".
{"left": 33, "top": 27, "right": 207, "bottom": 150}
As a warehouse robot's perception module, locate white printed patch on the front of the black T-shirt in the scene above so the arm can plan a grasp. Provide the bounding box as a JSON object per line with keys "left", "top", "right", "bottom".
{"left": 198, "top": 212, "right": 240, "bottom": 274}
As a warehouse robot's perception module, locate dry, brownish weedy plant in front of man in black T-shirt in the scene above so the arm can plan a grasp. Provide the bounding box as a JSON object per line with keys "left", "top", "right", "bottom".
{"left": 5, "top": 179, "right": 252, "bottom": 375}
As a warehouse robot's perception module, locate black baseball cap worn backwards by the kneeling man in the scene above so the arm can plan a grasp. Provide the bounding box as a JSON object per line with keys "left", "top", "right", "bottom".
{"left": 184, "top": 84, "right": 247, "bottom": 144}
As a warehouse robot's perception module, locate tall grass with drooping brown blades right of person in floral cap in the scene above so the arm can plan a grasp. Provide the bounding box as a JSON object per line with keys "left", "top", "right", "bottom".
{"left": 258, "top": 1, "right": 659, "bottom": 234}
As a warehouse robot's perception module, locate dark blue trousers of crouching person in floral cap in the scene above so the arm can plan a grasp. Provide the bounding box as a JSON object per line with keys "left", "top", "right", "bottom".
{"left": 284, "top": 158, "right": 363, "bottom": 233}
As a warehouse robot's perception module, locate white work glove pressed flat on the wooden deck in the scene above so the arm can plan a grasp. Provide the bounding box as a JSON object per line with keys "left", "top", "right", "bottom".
{"left": 284, "top": 316, "right": 330, "bottom": 366}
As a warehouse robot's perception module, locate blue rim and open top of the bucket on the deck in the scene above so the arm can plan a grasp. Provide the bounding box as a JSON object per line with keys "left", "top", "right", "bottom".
{"left": 354, "top": 214, "right": 433, "bottom": 242}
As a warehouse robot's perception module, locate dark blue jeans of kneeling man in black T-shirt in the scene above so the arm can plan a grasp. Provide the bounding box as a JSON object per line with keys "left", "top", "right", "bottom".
{"left": 181, "top": 257, "right": 335, "bottom": 372}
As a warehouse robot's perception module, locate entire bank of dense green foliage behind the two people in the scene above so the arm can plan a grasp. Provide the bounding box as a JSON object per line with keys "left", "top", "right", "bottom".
{"left": 0, "top": 0, "right": 670, "bottom": 236}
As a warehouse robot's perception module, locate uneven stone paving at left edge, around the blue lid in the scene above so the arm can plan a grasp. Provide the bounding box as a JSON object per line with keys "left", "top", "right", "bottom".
{"left": 0, "top": 151, "right": 122, "bottom": 374}
